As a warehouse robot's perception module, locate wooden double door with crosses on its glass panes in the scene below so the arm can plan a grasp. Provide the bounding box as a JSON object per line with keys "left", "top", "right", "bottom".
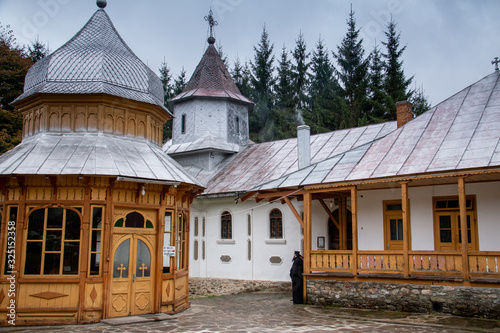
{"left": 108, "top": 234, "right": 155, "bottom": 317}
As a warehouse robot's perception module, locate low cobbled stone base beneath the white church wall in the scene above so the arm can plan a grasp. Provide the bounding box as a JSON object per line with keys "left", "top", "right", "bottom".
{"left": 189, "top": 277, "right": 292, "bottom": 298}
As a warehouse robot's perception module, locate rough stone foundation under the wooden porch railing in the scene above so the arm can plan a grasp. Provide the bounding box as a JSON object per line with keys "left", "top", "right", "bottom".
{"left": 307, "top": 279, "right": 500, "bottom": 319}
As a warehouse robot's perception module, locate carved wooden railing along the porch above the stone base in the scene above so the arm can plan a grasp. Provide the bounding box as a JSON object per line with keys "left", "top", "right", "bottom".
{"left": 310, "top": 250, "right": 500, "bottom": 279}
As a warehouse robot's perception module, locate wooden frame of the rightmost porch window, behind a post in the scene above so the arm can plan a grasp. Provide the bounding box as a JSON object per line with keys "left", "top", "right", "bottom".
{"left": 432, "top": 195, "right": 479, "bottom": 251}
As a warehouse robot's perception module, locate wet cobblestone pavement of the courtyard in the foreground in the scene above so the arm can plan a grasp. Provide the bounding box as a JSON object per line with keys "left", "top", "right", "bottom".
{"left": 0, "top": 293, "right": 500, "bottom": 333}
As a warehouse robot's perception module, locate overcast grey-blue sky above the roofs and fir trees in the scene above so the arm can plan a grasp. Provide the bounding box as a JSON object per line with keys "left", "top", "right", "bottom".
{"left": 0, "top": 0, "right": 500, "bottom": 105}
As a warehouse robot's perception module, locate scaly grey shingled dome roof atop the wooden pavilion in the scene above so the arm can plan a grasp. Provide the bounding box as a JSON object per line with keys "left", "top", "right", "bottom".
{"left": 14, "top": 9, "right": 166, "bottom": 110}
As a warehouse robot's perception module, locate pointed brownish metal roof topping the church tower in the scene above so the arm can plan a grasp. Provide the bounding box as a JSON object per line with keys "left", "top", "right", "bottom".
{"left": 170, "top": 39, "right": 253, "bottom": 104}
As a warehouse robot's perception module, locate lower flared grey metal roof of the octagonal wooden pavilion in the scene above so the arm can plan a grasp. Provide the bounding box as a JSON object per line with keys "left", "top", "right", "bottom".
{"left": 0, "top": 133, "right": 202, "bottom": 186}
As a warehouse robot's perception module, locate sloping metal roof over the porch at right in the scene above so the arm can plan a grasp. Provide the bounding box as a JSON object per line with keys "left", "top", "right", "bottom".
{"left": 252, "top": 71, "right": 500, "bottom": 191}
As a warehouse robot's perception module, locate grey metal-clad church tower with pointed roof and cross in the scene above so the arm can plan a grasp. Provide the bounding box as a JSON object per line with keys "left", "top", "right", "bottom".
{"left": 165, "top": 11, "right": 254, "bottom": 170}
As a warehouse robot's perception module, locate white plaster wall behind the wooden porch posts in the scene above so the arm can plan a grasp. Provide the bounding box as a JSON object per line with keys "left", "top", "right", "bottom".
{"left": 358, "top": 182, "right": 500, "bottom": 251}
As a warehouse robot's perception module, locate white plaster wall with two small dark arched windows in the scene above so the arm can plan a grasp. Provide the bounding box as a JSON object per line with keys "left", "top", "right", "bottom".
{"left": 190, "top": 197, "right": 302, "bottom": 281}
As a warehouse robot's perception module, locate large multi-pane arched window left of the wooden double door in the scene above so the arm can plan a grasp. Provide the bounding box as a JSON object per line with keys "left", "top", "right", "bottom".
{"left": 24, "top": 207, "right": 81, "bottom": 275}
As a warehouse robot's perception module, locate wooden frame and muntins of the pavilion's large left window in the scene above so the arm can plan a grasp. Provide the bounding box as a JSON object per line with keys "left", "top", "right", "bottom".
{"left": 21, "top": 205, "right": 83, "bottom": 277}
